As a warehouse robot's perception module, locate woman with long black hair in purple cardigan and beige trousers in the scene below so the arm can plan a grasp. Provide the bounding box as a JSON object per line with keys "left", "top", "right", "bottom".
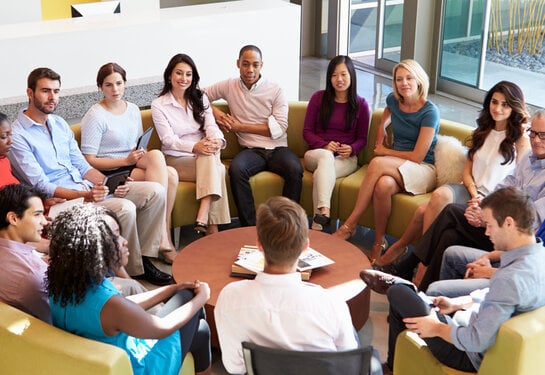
{"left": 303, "top": 56, "right": 369, "bottom": 230}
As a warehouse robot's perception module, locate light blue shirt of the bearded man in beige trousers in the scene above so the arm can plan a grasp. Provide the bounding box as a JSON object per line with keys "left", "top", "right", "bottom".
{"left": 9, "top": 109, "right": 92, "bottom": 196}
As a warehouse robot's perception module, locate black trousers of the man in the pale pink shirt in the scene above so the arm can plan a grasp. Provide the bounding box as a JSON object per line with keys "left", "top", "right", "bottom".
{"left": 229, "top": 147, "right": 303, "bottom": 227}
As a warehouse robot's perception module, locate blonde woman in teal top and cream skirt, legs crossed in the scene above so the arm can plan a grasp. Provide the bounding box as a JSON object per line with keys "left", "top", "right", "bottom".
{"left": 335, "top": 60, "right": 439, "bottom": 263}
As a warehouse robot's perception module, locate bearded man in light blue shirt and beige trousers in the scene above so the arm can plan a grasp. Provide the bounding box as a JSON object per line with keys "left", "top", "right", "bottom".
{"left": 9, "top": 68, "right": 172, "bottom": 285}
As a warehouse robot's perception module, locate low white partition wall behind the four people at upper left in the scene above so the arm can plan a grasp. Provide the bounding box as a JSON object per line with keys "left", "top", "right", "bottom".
{"left": 0, "top": 0, "right": 300, "bottom": 104}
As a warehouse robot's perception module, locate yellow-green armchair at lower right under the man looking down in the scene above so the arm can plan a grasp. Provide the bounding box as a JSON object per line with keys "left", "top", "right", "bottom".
{"left": 394, "top": 307, "right": 545, "bottom": 375}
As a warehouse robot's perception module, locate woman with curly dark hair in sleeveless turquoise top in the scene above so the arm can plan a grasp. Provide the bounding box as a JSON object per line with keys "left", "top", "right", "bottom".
{"left": 47, "top": 204, "right": 210, "bottom": 375}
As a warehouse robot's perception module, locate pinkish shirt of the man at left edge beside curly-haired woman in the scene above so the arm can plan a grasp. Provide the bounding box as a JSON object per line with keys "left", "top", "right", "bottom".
{"left": 0, "top": 238, "right": 51, "bottom": 323}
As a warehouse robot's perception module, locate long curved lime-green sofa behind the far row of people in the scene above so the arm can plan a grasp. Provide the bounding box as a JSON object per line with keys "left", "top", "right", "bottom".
{"left": 72, "top": 101, "right": 473, "bottom": 237}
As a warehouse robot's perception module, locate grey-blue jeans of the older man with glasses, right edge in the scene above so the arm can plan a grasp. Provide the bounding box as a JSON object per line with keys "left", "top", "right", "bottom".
{"left": 426, "top": 246, "right": 497, "bottom": 297}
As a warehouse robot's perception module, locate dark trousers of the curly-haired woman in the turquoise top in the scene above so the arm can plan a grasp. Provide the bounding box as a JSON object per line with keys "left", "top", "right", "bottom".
{"left": 157, "top": 289, "right": 212, "bottom": 372}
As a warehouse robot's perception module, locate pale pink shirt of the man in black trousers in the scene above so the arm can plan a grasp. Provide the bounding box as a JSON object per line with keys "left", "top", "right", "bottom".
{"left": 205, "top": 77, "right": 288, "bottom": 149}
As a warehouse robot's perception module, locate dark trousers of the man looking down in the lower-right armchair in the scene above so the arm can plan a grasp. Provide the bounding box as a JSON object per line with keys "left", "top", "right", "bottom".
{"left": 387, "top": 284, "right": 476, "bottom": 372}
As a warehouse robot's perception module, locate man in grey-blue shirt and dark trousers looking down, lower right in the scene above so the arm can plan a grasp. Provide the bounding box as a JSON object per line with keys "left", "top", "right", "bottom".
{"left": 380, "top": 187, "right": 545, "bottom": 372}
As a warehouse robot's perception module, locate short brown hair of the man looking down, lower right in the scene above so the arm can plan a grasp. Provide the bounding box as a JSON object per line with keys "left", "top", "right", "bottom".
{"left": 481, "top": 187, "right": 536, "bottom": 234}
